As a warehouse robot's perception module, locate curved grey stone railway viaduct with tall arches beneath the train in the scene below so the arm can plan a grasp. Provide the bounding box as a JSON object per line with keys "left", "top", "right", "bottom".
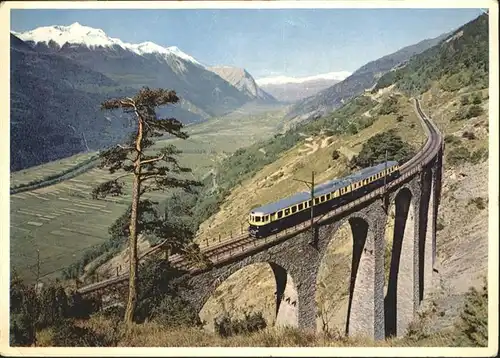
{"left": 80, "top": 101, "right": 444, "bottom": 339}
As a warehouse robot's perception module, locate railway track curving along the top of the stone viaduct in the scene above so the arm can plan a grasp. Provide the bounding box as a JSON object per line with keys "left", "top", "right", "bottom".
{"left": 78, "top": 99, "right": 442, "bottom": 294}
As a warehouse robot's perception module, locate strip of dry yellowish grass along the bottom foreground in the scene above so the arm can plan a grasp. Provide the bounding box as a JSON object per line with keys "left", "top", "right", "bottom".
{"left": 32, "top": 317, "right": 455, "bottom": 347}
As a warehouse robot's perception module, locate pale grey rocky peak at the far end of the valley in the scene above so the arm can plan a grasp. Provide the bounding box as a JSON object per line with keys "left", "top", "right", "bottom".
{"left": 207, "top": 66, "right": 276, "bottom": 101}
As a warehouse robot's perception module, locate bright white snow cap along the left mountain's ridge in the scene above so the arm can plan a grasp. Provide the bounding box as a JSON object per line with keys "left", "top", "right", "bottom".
{"left": 12, "top": 22, "right": 203, "bottom": 66}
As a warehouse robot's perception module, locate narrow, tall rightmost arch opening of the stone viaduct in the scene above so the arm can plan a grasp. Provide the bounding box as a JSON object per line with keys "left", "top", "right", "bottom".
{"left": 384, "top": 185, "right": 419, "bottom": 337}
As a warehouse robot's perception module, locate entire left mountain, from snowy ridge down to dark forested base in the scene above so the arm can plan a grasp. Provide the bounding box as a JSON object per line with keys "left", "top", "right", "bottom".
{"left": 10, "top": 23, "right": 278, "bottom": 170}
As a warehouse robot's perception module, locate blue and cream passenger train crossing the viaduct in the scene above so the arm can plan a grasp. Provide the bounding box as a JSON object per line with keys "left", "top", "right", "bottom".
{"left": 248, "top": 161, "right": 400, "bottom": 238}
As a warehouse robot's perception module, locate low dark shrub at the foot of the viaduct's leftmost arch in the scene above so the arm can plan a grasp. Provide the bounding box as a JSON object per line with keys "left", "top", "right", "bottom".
{"left": 214, "top": 312, "right": 267, "bottom": 337}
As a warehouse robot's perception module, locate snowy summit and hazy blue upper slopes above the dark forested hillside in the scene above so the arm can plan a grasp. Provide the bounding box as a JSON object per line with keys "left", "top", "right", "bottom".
{"left": 13, "top": 23, "right": 253, "bottom": 119}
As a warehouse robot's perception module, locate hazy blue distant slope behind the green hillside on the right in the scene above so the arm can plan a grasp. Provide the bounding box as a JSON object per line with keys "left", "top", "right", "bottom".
{"left": 287, "top": 34, "right": 448, "bottom": 122}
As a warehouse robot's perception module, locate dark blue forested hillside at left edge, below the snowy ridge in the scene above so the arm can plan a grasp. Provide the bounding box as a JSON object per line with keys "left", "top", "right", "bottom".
{"left": 10, "top": 35, "right": 131, "bottom": 171}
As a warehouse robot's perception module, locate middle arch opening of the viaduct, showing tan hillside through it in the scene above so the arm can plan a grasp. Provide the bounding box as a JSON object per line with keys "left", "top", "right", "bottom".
{"left": 316, "top": 211, "right": 383, "bottom": 337}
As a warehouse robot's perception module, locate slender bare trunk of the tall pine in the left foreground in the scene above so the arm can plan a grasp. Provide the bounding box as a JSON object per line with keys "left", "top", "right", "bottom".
{"left": 125, "top": 115, "right": 143, "bottom": 325}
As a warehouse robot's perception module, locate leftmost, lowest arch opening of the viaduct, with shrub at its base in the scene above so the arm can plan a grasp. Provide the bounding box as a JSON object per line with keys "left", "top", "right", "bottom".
{"left": 195, "top": 261, "right": 299, "bottom": 330}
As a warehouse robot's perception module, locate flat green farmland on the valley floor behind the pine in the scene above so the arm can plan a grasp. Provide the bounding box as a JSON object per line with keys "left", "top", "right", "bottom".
{"left": 10, "top": 106, "right": 288, "bottom": 280}
